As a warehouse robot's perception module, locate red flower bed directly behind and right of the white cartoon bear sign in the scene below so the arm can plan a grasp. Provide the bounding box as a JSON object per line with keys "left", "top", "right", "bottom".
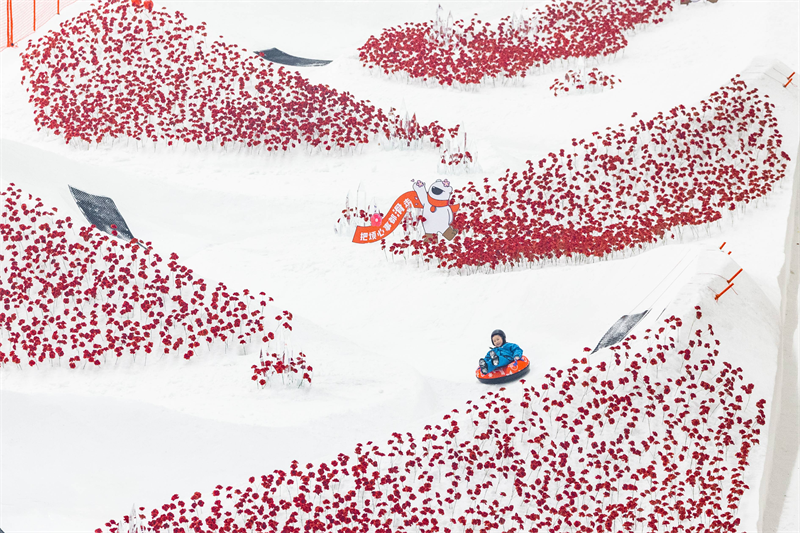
{"left": 389, "top": 75, "right": 789, "bottom": 269}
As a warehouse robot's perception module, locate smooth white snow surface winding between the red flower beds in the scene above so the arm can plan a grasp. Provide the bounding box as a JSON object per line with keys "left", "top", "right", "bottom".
{"left": 0, "top": 0, "right": 800, "bottom": 533}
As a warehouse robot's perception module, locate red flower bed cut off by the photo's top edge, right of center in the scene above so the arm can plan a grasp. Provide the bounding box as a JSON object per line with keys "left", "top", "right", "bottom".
{"left": 359, "top": 0, "right": 673, "bottom": 85}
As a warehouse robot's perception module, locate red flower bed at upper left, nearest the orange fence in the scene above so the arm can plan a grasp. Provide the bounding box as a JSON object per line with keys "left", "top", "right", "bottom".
{"left": 22, "top": 0, "right": 454, "bottom": 151}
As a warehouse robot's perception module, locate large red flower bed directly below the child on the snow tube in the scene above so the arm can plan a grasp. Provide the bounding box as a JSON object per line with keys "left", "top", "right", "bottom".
{"left": 97, "top": 307, "right": 765, "bottom": 533}
